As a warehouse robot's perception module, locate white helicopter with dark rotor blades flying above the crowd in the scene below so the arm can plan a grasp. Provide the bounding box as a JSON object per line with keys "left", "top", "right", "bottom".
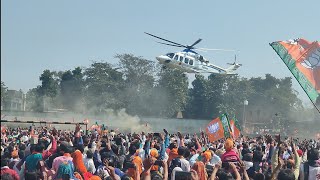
{"left": 145, "top": 32, "right": 242, "bottom": 75}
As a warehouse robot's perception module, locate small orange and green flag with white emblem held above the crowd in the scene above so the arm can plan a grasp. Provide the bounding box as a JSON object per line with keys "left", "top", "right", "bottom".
{"left": 206, "top": 114, "right": 231, "bottom": 142}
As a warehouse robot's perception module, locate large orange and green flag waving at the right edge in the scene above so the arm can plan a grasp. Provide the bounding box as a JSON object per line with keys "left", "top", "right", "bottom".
{"left": 270, "top": 39, "right": 320, "bottom": 104}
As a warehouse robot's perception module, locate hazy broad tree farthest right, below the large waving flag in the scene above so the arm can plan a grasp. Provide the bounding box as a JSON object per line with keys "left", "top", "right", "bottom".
{"left": 247, "top": 74, "right": 302, "bottom": 131}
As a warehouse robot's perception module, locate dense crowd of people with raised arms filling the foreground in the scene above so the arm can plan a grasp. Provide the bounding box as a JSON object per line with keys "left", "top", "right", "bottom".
{"left": 1, "top": 125, "right": 320, "bottom": 180}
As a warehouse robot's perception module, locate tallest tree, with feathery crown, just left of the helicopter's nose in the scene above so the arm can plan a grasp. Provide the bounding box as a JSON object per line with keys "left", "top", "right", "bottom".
{"left": 115, "top": 54, "right": 155, "bottom": 115}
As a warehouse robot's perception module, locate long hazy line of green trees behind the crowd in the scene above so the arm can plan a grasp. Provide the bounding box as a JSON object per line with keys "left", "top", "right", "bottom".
{"left": 1, "top": 54, "right": 318, "bottom": 125}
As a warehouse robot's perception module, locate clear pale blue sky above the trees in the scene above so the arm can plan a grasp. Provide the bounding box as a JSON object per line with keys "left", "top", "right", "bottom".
{"left": 1, "top": 0, "right": 320, "bottom": 106}
